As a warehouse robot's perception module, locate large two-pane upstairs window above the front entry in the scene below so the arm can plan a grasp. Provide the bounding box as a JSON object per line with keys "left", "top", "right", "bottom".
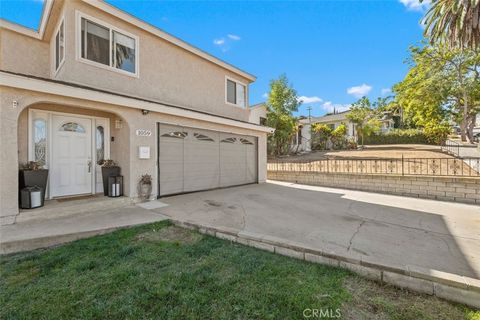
{"left": 80, "top": 17, "right": 138, "bottom": 75}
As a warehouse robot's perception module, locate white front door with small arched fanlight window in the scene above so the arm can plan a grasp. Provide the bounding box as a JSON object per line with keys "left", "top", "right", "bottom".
{"left": 50, "top": 115, "right": 94, "bottom": 197}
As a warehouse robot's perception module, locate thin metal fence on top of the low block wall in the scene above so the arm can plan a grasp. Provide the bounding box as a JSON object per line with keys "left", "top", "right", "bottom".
{"left": 267, "top": 157, "right": 480, "bottom": 177}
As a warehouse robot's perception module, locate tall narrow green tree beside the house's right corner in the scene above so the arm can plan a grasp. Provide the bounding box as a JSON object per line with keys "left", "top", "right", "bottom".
{"left": 266, "top": 74, "right": 300, "bottom": 156}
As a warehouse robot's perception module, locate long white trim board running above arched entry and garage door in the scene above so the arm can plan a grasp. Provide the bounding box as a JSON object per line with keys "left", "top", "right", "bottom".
{"left": 0, "top": 71, "right": 274, "bottom": 133}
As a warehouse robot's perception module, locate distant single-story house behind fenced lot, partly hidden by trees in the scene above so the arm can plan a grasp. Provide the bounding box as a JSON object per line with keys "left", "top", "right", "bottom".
{"left": 291, "top": 110, "right": 394, "bottom": 152}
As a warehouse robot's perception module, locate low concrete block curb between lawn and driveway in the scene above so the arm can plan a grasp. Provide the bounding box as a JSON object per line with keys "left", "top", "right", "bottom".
{"left": 171, "top": 219, "right": 480, "bottom": 309}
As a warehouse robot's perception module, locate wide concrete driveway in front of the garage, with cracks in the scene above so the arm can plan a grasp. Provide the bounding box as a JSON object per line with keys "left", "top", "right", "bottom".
{"left": 155, "top": 181, "right": 480, "bottom": 279}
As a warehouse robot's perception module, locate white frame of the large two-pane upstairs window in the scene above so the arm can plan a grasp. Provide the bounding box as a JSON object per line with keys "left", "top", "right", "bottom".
{"left": 75, "top": 10, "right": 140, "bottom": 78}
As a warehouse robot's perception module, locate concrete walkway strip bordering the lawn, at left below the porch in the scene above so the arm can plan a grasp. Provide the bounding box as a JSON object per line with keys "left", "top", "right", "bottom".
{"left": 0, "top": 206, "right": 168, "bottom": 254}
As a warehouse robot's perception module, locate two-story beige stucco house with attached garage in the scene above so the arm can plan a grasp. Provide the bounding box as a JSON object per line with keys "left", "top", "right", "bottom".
{"left": 0, "top": 0, "right": 273, "bottom": 224}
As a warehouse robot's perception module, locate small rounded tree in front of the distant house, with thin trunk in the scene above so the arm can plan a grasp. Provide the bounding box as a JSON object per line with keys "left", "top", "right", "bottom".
{"left": 347, "top": 97, "right": 381, "bottom": 146}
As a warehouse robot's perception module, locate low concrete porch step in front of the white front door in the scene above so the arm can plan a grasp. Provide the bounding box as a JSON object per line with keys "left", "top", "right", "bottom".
{"left": 15, "top": 196, "right": 134, "bottom": 223}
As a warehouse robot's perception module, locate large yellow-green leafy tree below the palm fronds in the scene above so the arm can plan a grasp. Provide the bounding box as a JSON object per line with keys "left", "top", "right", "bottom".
{"left": 394, "top": 45, "right": 480, "bottom": 141}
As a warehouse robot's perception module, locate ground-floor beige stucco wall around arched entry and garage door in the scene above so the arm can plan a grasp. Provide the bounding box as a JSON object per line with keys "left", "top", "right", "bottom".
{"left": 0, "top": 87, "right": 267, "bottom": 223}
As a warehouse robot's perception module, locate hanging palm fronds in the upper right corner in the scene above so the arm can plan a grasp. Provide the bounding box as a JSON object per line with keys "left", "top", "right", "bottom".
{"left": 420, "top": 0, "right": 480, "bottom": 49}
